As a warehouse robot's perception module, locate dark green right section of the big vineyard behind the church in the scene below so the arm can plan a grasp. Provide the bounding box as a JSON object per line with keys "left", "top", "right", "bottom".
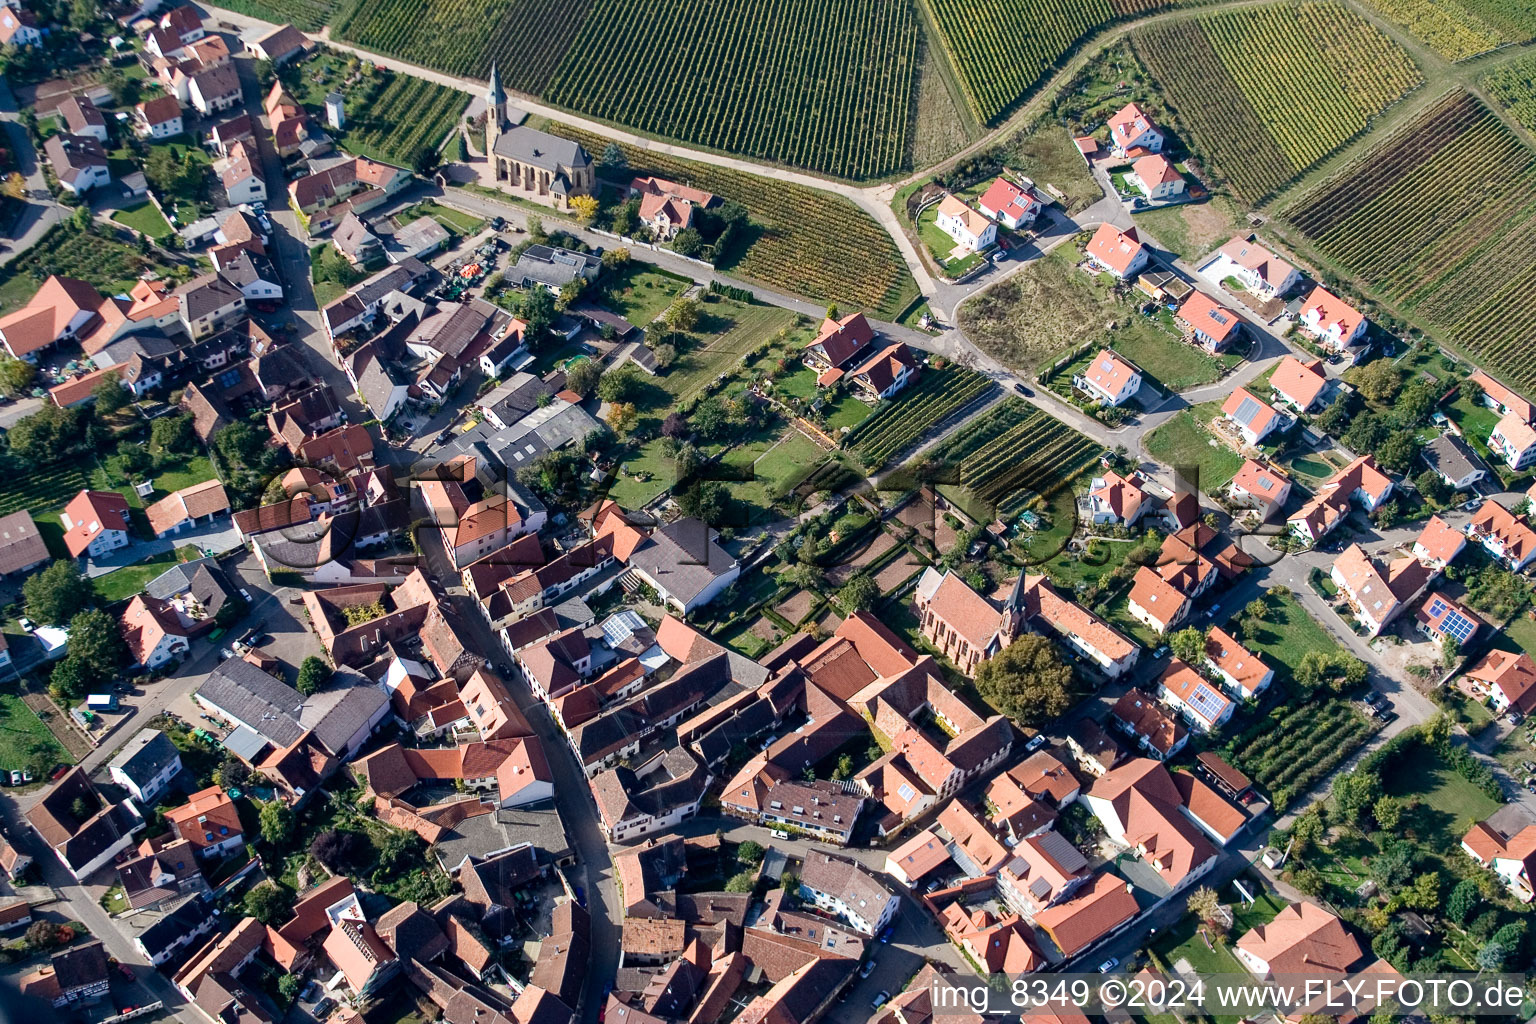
{"left": 545, "top": 0, "right": 919, "bottom": 178}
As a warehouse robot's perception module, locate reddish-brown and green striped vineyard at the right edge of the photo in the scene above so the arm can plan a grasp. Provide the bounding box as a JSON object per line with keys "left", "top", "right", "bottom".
{"left": 1286, "top": 91, "right": 1536, "bottom": 388}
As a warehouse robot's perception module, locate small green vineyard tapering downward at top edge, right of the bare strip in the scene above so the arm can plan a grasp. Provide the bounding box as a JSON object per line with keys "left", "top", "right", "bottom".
{"left": 932, "top": 0, "right": 1167, "bottom": 123}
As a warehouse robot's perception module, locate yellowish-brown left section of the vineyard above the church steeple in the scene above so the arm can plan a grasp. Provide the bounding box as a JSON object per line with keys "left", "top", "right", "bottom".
{"left": 330, "top": 0, "right": 591, "bottom": 95}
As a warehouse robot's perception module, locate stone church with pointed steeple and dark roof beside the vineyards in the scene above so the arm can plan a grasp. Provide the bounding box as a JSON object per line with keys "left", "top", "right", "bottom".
{"left": 485, "top": 64, "right": 598, "bottom": 210}
